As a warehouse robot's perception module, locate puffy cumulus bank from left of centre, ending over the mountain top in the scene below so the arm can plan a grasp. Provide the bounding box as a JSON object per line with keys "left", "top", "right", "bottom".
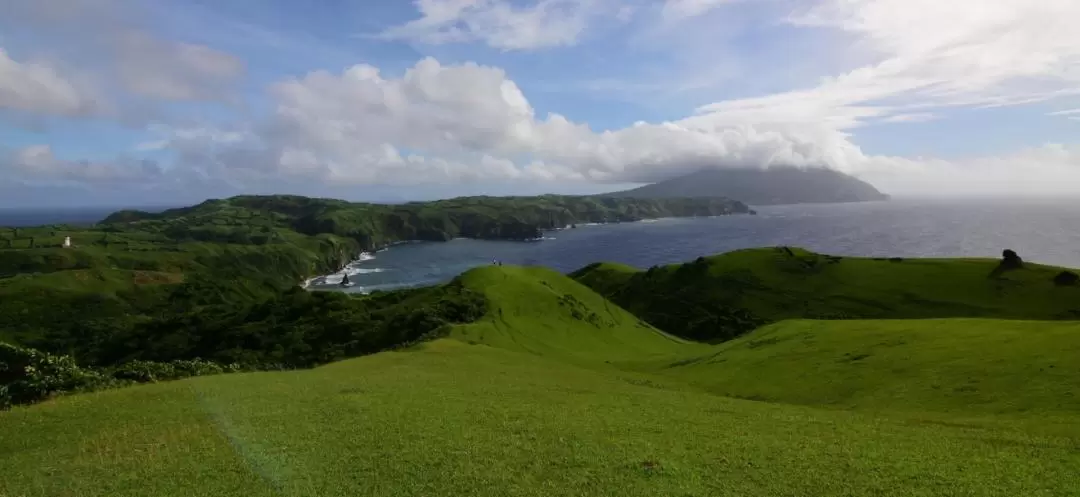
{"left": 128, "top": 58, "right": 876, "bottom": 184}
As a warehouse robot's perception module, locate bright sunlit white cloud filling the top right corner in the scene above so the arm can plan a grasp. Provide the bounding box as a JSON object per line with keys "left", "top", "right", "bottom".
{"left": 756, "top": 0, "right": 1080, "bottom": 127}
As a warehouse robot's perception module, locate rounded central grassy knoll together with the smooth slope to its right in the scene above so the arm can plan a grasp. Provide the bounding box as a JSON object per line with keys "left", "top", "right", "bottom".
{"left": 451, "top": 266, "right": 1080, "bottom": 416}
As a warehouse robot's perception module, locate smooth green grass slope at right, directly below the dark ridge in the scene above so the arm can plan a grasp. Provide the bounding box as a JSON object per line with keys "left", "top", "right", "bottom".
{"left": 643, "top": 319, "right": 1080, "bottom": 416}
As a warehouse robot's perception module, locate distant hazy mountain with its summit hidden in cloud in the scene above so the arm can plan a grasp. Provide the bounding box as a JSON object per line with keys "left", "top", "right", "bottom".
{"left": 605, "top": 167, "right": 889, "bottom": 205}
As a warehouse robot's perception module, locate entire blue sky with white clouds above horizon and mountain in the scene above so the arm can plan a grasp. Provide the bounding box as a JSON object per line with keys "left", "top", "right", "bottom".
{"left": 0, "top": 0, "right": 1080, "bottom": 207}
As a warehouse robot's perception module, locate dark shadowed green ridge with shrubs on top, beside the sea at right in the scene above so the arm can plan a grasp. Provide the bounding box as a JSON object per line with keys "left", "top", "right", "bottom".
{"left": 571, "top": 247, "right": 1080, "bottom": 341}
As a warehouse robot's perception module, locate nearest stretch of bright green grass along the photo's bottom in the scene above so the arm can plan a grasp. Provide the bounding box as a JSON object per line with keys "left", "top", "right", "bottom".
{"left": 0, "top": 340, "right": 1080, "bottom": 496}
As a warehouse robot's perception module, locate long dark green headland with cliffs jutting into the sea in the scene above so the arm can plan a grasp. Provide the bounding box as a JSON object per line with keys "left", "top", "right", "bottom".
{"left": 102, "top": 194, "right": 751, "bottom": 251}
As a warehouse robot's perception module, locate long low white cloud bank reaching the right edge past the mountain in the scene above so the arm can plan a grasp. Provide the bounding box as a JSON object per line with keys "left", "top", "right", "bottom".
{"left": 118, "top": 54, "right": 1080, "bottom": 193}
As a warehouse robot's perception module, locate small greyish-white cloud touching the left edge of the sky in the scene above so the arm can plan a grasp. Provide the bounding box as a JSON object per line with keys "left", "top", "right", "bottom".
{"left": 0, "top": 49, "right": 99, "bottom": 117}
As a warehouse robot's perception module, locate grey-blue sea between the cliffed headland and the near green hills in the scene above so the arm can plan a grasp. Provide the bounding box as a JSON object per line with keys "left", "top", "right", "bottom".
{"left": 312, "top": 199, "right": 1080, "bottom": 292}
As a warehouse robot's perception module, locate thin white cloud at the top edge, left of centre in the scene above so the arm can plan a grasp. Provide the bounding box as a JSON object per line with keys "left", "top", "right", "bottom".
{"left": 379, "top": 0, "right": 600, "bottom": 50}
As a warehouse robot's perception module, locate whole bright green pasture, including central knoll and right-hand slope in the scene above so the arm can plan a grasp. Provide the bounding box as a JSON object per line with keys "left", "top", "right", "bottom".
{"left": 6, "top": 262, "right": 1080, "bottom": 497}
